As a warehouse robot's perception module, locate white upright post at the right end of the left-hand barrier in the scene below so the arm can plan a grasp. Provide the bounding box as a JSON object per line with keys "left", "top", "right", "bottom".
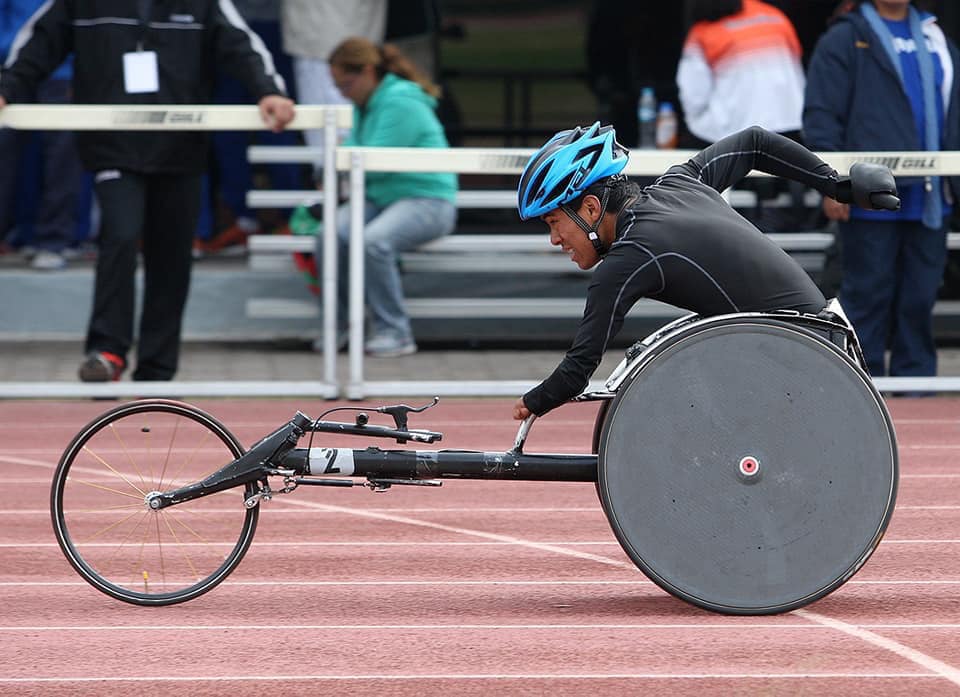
{"left": 321, "top": 109, "right": 338, "bottom": 385}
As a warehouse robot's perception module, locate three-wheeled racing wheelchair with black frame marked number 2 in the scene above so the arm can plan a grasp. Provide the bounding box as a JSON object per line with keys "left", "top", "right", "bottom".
{"left": 51, "top": 304, "right": 898, "bottom": 615}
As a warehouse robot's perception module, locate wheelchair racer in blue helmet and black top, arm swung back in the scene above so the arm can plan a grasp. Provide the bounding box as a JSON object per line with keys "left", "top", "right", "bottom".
{"left": 513, "top": 122, "right": 900, "bottom": 420}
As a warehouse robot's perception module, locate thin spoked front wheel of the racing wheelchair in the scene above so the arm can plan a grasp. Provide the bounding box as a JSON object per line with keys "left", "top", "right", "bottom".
{"left": 50, "top": 399, "right": 259, "bottom": 605}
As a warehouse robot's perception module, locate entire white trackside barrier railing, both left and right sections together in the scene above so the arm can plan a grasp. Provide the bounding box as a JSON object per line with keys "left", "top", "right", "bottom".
{"left": 0, "top": 105, "right": 960, "bottom": 399}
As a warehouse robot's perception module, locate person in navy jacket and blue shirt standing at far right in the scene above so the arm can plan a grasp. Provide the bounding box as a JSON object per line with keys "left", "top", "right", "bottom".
{"left": 803, "top": 0, "right": 960, "bottom": 376}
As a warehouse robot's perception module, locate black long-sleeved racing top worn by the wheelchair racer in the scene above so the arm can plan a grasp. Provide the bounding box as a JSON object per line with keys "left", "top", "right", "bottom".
{"left": 523, "top": 127, "right": 850, "bottom": 416}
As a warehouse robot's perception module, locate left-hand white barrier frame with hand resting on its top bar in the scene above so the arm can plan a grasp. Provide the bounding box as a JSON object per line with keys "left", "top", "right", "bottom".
{"left": 0, "top": 104, "right": 353, "bottom": 399}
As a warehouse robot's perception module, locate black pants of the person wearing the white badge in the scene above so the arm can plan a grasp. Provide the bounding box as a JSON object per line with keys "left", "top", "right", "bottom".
{"left": 86, "top": 170, "right": 202, "bottom": 380}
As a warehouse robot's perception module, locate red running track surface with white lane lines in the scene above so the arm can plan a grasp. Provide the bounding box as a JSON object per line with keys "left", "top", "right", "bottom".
{"left": 0, "top": 398, "right": 960, "bottom": 695}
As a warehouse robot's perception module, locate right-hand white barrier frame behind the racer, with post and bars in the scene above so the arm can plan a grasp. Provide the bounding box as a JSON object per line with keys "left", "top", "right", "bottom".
{"left": 336, "top": 147, "right": 960, "bottom": 399}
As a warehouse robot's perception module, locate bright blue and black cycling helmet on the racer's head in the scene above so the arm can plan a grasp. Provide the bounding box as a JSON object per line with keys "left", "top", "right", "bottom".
{"left": 517, "top": 121, "right": 630, "bottom": 220}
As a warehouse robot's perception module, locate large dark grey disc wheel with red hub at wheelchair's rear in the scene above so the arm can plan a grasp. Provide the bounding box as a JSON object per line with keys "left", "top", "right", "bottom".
{"left": 598, "top": 317, "right": 898, "bottom": 615}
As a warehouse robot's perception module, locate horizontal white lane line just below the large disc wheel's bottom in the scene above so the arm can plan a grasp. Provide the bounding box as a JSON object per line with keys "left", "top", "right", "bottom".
{"left": 0, "top": 620, "right": 960, "bottom": 632}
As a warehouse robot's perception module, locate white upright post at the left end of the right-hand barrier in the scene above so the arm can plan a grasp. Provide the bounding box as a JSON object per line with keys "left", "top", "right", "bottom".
{"left": 347, "top": 152, "right": 366, "bottom": 399}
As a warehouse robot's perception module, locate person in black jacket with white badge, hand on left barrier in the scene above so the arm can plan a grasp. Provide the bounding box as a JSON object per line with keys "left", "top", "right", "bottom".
{"left": 0, "top": 0, "right": 294, "bottom": 382}
